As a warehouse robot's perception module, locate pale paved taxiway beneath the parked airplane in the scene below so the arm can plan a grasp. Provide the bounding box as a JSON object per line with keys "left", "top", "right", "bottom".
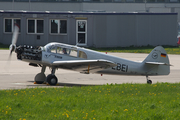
{"left": 0, "top": 50, "right": 180, "bottom": 89}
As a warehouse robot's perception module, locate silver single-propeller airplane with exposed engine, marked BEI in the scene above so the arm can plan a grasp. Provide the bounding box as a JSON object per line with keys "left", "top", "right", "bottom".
{"left": 10, "top": 25, "right": 171, "bottom": 85}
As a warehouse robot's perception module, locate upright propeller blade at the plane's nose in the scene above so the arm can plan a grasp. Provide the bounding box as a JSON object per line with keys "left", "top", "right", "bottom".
{"left": 9, "top": 24, "right": 19, "bottom": 57}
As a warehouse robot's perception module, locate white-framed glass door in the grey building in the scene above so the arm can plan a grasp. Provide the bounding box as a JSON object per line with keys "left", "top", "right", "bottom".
{"left": 76, "top": 20, "right": 87, "bottom": 46}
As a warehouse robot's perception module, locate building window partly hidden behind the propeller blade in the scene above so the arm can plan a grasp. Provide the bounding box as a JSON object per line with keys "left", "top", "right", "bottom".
{"left": 4, "top": 18, "right": 21, "bottom": 33}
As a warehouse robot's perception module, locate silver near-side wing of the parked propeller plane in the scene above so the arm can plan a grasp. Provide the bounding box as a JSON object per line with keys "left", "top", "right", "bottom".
{"left": 51, "top": 59, "right": 117, "bottom": 74}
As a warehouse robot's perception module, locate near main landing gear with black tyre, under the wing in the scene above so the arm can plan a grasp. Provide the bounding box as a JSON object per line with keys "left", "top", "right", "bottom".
{"left": 46, "top": 68, "right": 58, "bottom": 85}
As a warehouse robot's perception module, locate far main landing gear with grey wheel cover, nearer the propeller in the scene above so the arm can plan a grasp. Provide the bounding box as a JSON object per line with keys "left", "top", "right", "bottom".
{"left": 34, "top": 66, "right": 46, "bottom": 84}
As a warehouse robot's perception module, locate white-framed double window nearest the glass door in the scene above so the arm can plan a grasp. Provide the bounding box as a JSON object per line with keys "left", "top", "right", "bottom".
{"left": 50, "top": 19, "right": 67, "bottom": 34}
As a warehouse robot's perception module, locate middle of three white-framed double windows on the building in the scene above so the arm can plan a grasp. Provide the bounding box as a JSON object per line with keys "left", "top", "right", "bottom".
{"left": 28, "top": 19, "right": 44, "bottom": 33}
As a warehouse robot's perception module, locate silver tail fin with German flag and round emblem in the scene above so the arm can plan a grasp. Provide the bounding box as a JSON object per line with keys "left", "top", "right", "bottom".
{"left": 143, "top": 46, "right": 171, "bottom": 75}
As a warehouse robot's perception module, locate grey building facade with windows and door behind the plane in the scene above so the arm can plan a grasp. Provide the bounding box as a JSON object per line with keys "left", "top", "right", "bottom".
{"left": 0, "top": 0, "right": 180, "bottom": 47}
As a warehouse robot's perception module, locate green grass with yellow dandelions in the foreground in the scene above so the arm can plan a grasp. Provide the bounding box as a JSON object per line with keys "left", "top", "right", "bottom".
{"left": 0, "top": 83, "right": 180, "bottom": 120}
